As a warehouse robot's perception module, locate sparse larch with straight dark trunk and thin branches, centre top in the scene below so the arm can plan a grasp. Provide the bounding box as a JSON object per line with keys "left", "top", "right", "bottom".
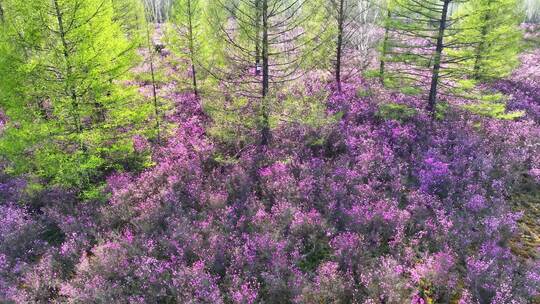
{"left": 215, "top": 0, "right": 322, "bottom": 146}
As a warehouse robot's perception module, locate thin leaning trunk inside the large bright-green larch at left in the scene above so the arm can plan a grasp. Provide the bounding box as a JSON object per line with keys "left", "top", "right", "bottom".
{"left": 53, "top": 0, "right": 85, "bottom": 151}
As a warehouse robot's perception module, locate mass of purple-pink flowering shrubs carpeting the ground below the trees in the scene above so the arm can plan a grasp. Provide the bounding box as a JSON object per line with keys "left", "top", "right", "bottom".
{"left": 0, "top": 69, "right": 540, "bottom": 304}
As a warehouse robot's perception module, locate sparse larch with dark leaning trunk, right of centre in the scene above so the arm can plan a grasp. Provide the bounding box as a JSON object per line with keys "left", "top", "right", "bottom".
{"left": 385, "top": 0, "right": 467, "bottom": 114}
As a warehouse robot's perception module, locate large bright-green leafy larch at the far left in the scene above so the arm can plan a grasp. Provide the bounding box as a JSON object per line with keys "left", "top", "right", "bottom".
{"left": 0, "top": 0, "right": 148, "bottom": 194}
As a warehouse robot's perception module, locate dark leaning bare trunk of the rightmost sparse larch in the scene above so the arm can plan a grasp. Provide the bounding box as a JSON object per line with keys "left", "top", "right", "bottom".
{"left": 428, "top": 0, "right": 452, "bottom": 115}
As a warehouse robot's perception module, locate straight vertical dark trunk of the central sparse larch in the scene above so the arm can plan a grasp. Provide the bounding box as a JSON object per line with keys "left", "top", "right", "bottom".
{"left": 261, "top": 0, "right": 270, "bottom": 146}
